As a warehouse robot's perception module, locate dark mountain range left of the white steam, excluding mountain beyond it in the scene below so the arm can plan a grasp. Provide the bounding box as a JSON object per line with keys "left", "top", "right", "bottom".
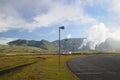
{"left": 8, "top": 38, "right": 85, "bottom": 51}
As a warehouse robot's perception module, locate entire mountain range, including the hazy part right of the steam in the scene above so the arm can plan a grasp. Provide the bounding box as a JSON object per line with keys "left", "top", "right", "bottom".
{"left": 8, "top": 38, "right": 120, "bottom": 51}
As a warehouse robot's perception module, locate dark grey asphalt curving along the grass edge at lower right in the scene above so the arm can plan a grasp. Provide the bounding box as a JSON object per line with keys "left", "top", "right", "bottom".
{"left": 67, "top": 55, "right": 120, "bottom": 80}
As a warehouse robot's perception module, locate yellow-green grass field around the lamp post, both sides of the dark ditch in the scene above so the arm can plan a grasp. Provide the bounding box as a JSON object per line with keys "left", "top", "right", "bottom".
{"left": 0, "top": 55, "right": 80, "bottom": 80}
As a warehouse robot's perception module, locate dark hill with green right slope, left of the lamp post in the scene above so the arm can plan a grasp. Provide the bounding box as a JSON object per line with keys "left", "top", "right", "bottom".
{"left": 8, "top": 39, "right": 57, "bottom": 51}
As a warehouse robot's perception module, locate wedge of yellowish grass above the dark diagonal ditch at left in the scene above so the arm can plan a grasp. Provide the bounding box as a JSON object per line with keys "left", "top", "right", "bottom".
{"left": 0, "top": 56, "right": 38, "bottom": 71}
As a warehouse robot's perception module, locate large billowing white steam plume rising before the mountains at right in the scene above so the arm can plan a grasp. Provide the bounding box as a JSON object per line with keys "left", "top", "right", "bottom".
{"left": 79, "top": 23, "right": 120, "bottom": 50}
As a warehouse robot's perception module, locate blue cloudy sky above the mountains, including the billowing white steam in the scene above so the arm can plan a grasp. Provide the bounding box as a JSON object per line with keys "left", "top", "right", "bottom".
{"left": 0, "top": 0, "right": 120, "bottom": 46}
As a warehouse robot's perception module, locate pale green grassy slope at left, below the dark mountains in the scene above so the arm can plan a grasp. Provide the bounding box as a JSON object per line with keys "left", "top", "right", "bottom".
{"left": 0, "top": 45, "right": 55, "bottom": 55}
